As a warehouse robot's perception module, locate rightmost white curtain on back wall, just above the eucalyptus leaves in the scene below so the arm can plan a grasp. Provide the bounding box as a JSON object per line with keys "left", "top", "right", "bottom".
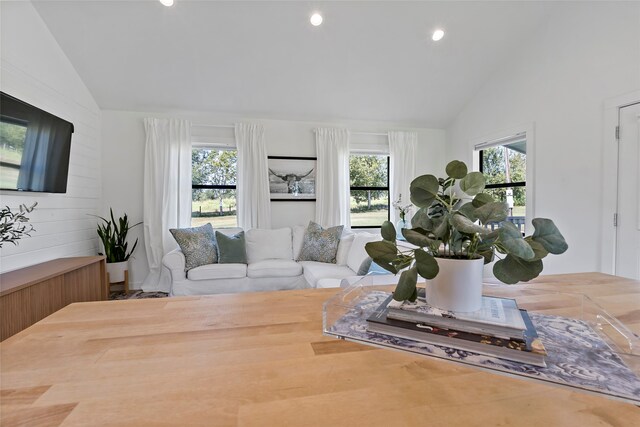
{"left": 389, "top": 131, "right": 418, "bottom": 224}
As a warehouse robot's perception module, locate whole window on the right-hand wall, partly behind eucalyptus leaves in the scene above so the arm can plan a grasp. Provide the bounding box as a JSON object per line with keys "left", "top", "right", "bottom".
{"left": 478, "top": 135, "right": 527, "bottom": 233}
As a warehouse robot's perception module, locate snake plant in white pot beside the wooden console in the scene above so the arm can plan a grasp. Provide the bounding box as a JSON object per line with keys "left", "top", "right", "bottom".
{"left": 97, "top": 209, "right": 142, "bottom": 283}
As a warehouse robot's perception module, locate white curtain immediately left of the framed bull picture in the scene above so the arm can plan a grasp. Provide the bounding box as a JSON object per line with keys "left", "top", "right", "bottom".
{"left": 235, "top": 123, "right": 271, "bottom": 230}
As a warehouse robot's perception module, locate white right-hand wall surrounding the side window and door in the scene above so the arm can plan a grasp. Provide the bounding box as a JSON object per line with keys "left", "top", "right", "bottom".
{"left": 447, "top": 2, "right": 640, "bottom": 273}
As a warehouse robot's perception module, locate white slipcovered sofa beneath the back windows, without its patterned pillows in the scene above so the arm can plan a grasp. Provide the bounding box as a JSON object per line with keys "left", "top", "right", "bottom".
{"left": 162, "top": 226, "right": 381, "bottom": 296}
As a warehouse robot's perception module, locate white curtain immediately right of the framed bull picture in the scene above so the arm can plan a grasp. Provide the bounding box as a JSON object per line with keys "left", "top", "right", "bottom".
{"left": 315, "top": 129, "right": 351, "bottom": 228}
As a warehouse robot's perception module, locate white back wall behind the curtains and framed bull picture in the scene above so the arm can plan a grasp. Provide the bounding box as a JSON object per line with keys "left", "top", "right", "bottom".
{"left": 102, "top": 110, "right": 445, "bottom": 287}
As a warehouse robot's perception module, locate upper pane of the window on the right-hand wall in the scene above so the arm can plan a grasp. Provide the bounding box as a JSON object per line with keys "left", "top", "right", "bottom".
{"left": 482, "top": 142, "right": 527, "bottom": 184}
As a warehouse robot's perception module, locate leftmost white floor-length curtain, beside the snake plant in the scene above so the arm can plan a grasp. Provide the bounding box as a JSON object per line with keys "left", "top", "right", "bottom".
{"left": 142, "top": 119, "right": 191, "bottom": 292}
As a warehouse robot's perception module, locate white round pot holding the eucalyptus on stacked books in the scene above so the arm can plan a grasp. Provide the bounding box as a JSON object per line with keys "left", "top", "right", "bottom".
{"left": 425, "top": 258, "right": 484, "bottom": 312}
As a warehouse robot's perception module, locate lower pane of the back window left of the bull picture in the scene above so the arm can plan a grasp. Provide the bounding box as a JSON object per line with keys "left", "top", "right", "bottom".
{"left": 191, "top": 190, "right": 238, "bottom": 228}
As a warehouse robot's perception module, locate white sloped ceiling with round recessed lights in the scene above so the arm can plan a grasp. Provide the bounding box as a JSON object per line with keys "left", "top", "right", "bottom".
{"left": 34, "top": 0, "right": 553, "bottom": 127}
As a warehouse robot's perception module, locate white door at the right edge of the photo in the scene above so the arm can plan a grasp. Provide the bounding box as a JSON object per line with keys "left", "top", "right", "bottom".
{"left": 615, "top": 103, "right": 640, "bottom": 280}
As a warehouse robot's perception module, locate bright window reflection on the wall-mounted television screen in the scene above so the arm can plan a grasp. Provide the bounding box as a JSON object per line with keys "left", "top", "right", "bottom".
{"left": 0, "top": 122, "right": 27, "bottom": 188}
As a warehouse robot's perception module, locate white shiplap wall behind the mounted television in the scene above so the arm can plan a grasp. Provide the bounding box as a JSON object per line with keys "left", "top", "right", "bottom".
{"left": 0, "top": 2, "right": 102, "bottom": 271}
